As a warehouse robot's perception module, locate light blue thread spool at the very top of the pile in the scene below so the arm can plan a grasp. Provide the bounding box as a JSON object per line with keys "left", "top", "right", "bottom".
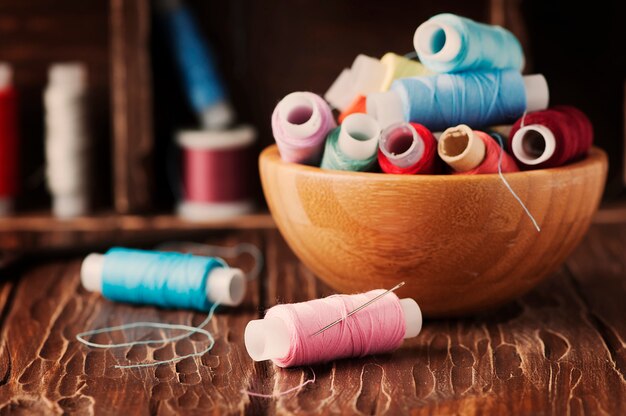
{"left": 413, "top": 13, "right": 524, "bottom": 72}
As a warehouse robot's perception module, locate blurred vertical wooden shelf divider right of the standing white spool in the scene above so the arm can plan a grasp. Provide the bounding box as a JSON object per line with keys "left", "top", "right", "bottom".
{"left": 110, "top": 0, "right": 154, "bottom": 213}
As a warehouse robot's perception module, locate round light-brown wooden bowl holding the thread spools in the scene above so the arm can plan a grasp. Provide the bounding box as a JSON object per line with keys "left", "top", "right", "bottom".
{"left": 259, "top": 146, "right": 607, "bottom": 316}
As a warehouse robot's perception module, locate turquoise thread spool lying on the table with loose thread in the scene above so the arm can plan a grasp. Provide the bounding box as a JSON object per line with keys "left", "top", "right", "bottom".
{"left": 80, "top": 247, "right": 246, "bottom": 311}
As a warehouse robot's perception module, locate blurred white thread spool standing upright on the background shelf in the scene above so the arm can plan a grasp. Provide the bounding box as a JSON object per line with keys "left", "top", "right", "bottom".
{"left": 44, "top": 63, "right": 90, "bottom": 218}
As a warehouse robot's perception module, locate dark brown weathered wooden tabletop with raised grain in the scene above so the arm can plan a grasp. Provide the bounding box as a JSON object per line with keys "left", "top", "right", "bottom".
{"left": 0, "top": 224, "right": 626, "bottom": 415}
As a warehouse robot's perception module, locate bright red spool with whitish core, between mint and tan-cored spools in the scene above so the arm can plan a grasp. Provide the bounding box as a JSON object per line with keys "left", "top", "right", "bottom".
{"left": 378, "top": 123, "right": 438, "bottom": 175}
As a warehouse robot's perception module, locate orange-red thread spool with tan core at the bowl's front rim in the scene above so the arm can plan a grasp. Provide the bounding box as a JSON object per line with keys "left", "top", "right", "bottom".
{"left": 438, "top": 124, "right": 519, "bottom": 175}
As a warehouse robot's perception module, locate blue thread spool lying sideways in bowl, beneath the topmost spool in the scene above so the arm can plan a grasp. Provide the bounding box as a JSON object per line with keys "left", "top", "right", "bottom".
{"left": 367, "top": 69, "right": 549, "bottom": 130}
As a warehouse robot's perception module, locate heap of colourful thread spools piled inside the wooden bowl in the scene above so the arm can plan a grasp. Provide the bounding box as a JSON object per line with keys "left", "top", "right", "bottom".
{"left": 272, "top": 14, "right": 593, "bottom": 174}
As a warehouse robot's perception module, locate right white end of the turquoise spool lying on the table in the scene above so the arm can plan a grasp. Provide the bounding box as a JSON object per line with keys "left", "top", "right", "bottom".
{"left": 206, "top": 267, "right": 246, "bottom": 306}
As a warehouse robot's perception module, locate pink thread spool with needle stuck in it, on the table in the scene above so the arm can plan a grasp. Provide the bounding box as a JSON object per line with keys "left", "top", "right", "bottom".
{"left": 244, "top": 289, "right": 422, "bottom": 367}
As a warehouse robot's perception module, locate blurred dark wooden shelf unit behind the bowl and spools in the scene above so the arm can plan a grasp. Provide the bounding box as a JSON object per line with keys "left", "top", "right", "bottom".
{"left": 0, "top": 0, "right": 626, "bottom": 251}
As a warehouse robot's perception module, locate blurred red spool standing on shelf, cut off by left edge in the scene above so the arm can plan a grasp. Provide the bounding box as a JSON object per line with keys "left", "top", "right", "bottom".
{"left": 0, "top": 63, "right": 18, "bottom": 215}
